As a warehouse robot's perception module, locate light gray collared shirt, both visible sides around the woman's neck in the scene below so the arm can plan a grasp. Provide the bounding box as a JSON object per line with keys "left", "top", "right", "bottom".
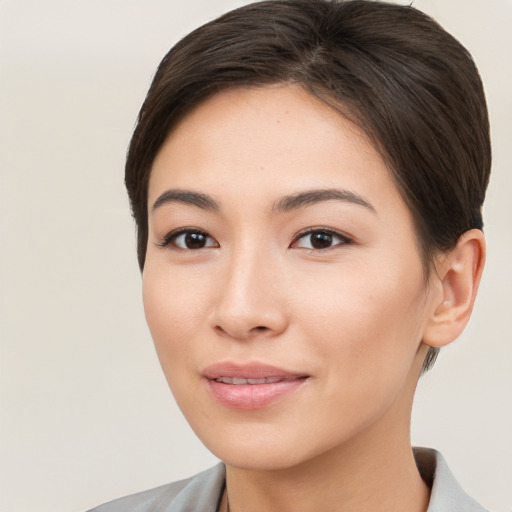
{"left": 89, "top": 448, "right": 488, "bottom": 512}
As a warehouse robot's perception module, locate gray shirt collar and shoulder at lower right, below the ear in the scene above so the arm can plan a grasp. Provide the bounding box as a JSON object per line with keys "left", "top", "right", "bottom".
{"left": 414, "top": 448, "right": 488, "bottom": 512}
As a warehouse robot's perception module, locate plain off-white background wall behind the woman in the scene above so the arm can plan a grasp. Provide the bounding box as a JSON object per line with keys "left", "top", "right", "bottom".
{"left": 0, "top": 0, "right": 512, "bottom": 512}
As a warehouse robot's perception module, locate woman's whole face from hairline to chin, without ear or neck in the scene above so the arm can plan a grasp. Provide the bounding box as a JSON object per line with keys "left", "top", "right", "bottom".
{"left": 143, "top": 86, "right": 434, "bottom": 469}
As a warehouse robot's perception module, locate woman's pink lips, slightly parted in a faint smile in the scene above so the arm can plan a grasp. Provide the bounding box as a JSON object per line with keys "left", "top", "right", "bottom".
{"left": 203, "top": 363, "right": 309, "bottom": 410}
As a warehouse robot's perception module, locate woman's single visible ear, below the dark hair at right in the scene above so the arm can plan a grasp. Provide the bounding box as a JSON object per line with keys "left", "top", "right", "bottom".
{"left": 423, "top": 229, "right": 485, "bottom": 348}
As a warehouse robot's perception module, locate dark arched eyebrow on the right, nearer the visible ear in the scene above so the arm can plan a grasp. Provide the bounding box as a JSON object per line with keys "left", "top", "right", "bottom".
{"left": 272, "top": 188, "right": 377, "bottom": 213}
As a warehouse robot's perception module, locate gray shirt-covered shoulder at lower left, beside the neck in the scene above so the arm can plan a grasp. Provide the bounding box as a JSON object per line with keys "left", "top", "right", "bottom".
{"left": 88, "top": 464, "right": 226, "bottom": 512}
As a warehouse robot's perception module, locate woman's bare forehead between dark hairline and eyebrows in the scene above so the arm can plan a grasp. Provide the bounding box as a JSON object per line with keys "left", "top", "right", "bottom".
{"left": 149, "top": 85, "right": 401, "bottom": 213}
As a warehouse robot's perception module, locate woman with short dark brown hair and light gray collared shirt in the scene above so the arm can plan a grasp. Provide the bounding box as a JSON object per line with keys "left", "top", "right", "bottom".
{"left": 89, "top": 0, "right": 490, "bottom": 512}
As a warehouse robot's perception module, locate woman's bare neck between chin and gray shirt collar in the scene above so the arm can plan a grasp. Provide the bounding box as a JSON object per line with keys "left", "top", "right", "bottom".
{"left": 227, "top": 434, "right": 429, "bottom": 512}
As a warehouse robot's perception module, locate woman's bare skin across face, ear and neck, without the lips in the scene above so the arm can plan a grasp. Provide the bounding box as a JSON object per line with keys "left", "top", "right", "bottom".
{"left": 143, "top": 86, "right": 483, "bottom": 512}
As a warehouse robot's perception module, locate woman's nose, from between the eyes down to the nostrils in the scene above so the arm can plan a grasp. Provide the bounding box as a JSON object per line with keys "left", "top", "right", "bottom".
{"left": 212, "top": 250, "right": 288, "bottom": 340}
